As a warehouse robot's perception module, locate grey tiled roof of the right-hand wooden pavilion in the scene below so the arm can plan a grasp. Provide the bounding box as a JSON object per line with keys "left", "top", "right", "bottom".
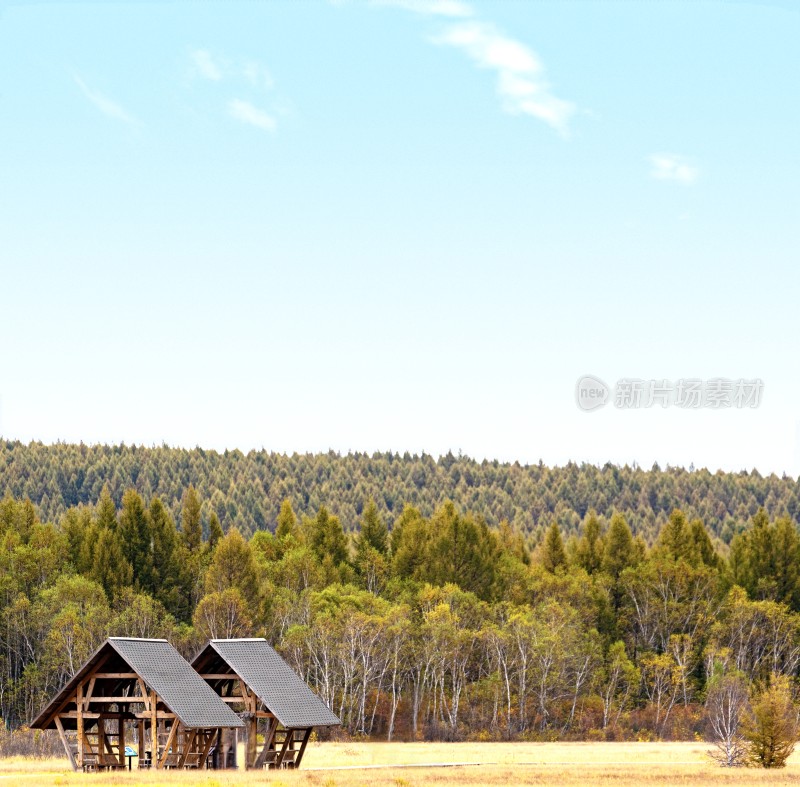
{"left": 197, "top": 638, "right": 341, "bottom": 728}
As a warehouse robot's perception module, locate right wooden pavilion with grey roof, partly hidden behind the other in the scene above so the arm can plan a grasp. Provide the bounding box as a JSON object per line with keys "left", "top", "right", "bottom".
{"left": 192, "top": 639, "right": 341, "bottom": 769}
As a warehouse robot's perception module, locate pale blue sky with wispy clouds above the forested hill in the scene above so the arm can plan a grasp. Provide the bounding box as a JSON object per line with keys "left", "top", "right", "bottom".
{"left": 0, "top": 0, "right": 800, "bottom": 475}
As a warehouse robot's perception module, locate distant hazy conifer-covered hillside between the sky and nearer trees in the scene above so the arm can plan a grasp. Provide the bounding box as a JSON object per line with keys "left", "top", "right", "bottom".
{"left": 0, "top": 440, "right": 800, "bottom": 546}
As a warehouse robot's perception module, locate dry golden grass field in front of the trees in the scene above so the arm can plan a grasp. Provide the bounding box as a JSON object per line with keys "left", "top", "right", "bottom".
{"left": 0, "top": 743, "right": 800, "bottom": 787}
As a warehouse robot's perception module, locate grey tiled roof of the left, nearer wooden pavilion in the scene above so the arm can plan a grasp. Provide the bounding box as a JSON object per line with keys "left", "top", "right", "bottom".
{"left": 31, "top": 637, "right": 244, "bottom": 729}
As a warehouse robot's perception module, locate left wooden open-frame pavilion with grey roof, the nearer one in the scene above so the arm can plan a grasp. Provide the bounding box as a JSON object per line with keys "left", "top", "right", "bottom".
{"left": 31, "top": 637, "right": 244, "bottom": 770}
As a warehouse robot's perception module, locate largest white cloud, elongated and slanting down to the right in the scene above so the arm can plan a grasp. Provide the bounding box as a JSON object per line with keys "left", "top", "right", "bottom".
{"left": 433, "top": 22, "right": 575, "bottom": 135}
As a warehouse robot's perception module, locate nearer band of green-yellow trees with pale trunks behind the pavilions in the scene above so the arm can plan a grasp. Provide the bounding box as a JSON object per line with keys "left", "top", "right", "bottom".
{"left": 0, "top": 486, "right": 800, "bottom": 760}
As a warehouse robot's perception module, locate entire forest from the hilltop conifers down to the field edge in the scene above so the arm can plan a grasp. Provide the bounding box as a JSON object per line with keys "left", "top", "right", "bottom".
{"left": 0, "top": 443, "right": 800, "bottom": 739}
